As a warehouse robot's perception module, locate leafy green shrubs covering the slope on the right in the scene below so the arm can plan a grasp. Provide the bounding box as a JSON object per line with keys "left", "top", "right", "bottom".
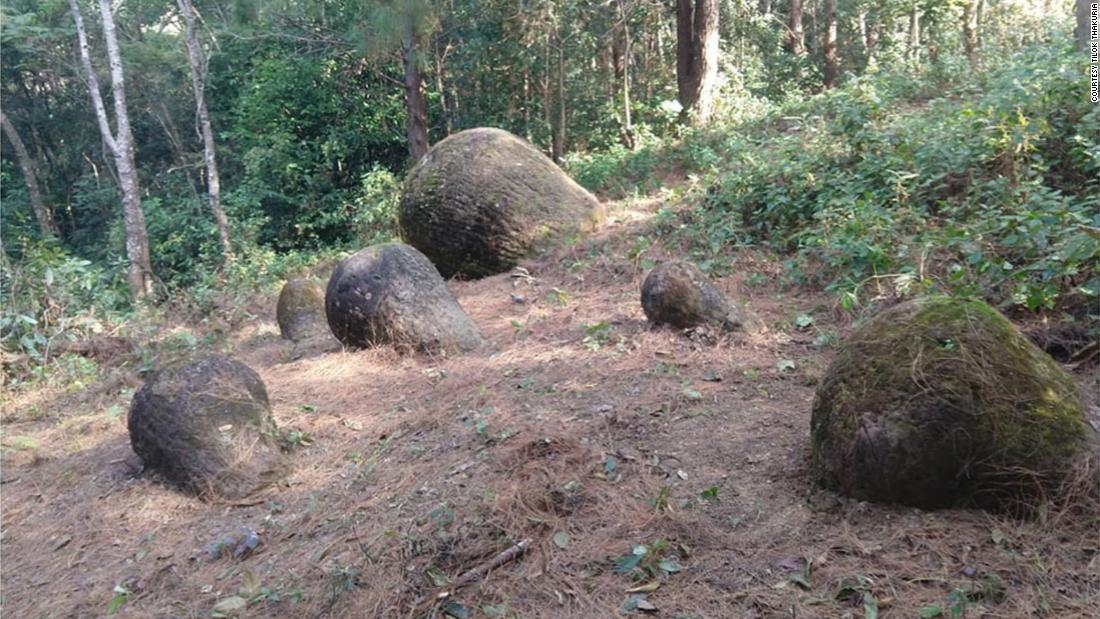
{"left": 664, "top": 41, "right": 1100, "bottom": 319}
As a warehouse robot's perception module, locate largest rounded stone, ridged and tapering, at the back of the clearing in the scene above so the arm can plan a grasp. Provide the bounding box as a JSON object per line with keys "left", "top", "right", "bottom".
{"left": 398, "top": 128, "right": 605, "bottom": 278}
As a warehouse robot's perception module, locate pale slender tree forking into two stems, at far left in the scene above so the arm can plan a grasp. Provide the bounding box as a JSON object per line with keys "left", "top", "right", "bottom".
{"left": 69, "top": 0, "right": 153, "bottom": 299}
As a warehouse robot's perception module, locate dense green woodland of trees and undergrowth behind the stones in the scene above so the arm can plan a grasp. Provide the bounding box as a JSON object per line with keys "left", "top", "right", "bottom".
{"left": 0, "top": 0, "right": 1100, "bottom": 361}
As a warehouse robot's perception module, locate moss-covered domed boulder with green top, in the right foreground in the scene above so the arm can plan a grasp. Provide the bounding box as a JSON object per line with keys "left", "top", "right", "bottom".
{"left": 811, "top": 297, "right": 1087, "bottom": 508}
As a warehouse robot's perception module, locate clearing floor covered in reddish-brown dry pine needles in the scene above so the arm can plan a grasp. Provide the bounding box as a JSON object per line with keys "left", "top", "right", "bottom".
{"left": 0, "top": 200, "right": 1100, "bottom": 618}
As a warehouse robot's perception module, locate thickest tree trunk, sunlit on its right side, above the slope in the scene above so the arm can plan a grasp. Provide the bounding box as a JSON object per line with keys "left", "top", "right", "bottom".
{"left": 677, "top": 0, "right": 718, "bottom": 125}
